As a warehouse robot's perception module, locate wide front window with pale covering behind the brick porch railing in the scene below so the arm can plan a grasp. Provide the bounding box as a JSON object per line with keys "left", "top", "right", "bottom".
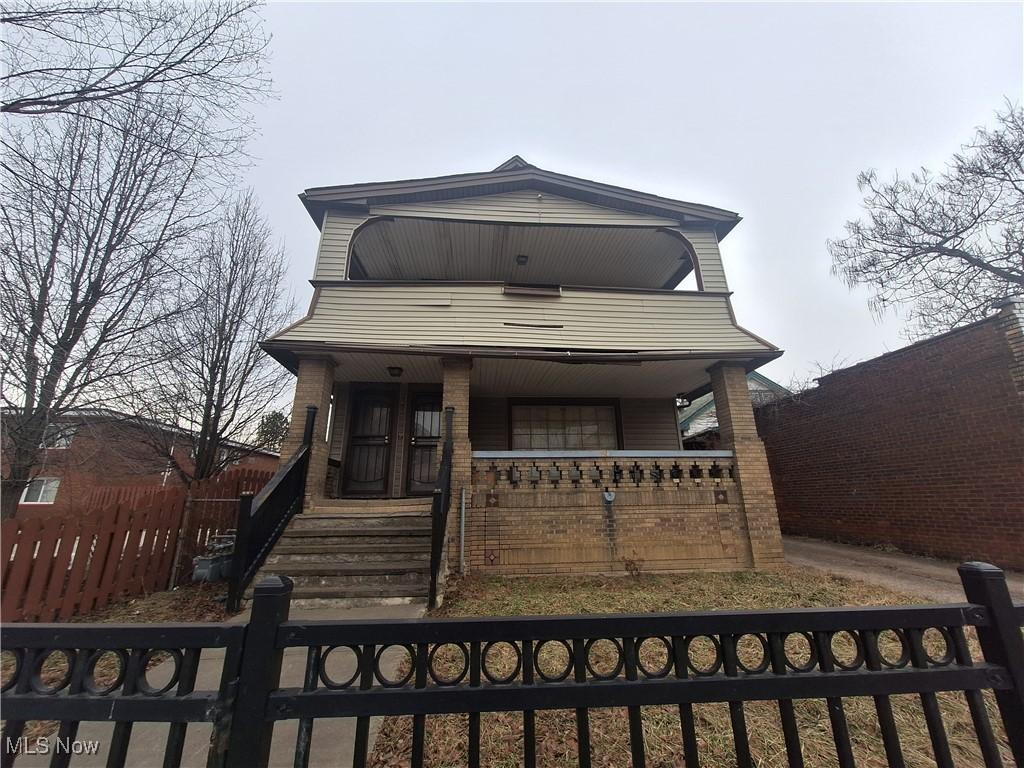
{"left": 511, "top": 402, "right": 618, "bottom": 451}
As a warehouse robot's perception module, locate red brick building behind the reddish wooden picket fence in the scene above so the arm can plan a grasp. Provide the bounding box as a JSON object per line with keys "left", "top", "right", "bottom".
{"left": 3, "top": 409, "right": 279, "bottom": 517}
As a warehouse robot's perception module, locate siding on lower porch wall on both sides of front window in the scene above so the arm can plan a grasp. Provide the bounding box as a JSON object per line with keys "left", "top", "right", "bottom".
{"left": 469, "top": 395, "right": 679, "bottom": 451}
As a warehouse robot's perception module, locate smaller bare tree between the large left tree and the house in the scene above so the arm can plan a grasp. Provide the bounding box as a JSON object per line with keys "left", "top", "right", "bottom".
{"left": 138, "top": 190, "right": 294, "bottom": 482}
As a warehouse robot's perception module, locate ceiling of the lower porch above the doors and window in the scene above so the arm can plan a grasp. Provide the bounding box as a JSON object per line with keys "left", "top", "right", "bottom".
{"left": 321, "top": 351, "right": 737, "bottom": 397}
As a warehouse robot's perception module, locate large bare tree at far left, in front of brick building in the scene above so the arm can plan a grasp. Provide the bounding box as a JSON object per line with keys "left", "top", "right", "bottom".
{"left": 0, "top": 101, "right": 206, "bottom": 517}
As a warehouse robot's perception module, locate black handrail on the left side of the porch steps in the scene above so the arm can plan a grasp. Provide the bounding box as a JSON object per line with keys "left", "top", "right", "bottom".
{"left": 227, "top": 406, "right": 316, "bottom": 611}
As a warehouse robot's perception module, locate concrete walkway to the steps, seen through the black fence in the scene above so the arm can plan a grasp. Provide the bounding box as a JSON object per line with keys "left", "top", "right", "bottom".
{"left": 16, "top": 604, "right": 424, "bottom": 768}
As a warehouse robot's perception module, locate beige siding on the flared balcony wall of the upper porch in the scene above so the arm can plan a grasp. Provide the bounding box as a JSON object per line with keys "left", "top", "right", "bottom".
{"left": 274, "top": 283, "right": 766, "bottom": 352}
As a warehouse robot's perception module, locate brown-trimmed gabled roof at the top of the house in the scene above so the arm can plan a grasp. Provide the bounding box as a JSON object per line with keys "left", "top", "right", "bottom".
{"left": 299, "top": 155, "right": 740, "bottom": 240}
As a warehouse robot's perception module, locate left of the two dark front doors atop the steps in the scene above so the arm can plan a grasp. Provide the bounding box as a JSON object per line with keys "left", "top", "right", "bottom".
{"left": 341, "top": 389, "right": 395, "bottom": 496}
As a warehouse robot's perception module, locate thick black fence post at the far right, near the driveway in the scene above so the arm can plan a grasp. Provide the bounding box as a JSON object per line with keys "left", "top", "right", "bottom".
{"left": 956, "top": 562, "right": 1024, "bottom": 766}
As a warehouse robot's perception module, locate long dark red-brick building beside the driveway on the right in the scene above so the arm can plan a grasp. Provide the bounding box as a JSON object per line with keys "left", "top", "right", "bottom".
{"left": 757, "top": 300, "right": 1024, "bottom": 568}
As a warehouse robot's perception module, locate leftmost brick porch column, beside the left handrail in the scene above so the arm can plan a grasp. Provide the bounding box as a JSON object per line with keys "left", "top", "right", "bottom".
{"left": 281, "top": 357, "right": 334, "bottom": 509}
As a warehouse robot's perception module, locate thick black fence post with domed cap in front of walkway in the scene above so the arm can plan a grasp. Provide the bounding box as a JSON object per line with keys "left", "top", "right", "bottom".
{"left": 226, "top": 577, "right": 292, "bottom": 768}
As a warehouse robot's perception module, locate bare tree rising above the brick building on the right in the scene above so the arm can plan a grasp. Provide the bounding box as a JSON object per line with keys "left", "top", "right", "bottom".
{"left": 828, "top": 103, "right": 1024, "bottom": 338}
